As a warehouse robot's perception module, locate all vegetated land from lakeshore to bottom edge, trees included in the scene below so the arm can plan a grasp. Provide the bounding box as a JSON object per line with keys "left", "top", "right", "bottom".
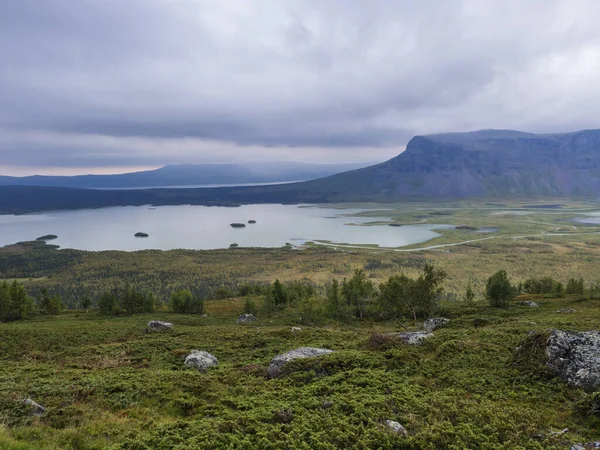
{"left": 0, "top": 202, "right": 600, "bottom": 449}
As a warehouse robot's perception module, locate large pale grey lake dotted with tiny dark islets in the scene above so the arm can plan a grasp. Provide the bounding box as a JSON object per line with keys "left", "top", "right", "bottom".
{"left": 0, "top": 204, "right": 445, "bottom": 251}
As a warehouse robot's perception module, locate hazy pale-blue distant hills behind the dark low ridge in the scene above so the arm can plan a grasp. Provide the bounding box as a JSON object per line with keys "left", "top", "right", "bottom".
{"left": 0, "top": 162, "right": 372, "bottom": 189}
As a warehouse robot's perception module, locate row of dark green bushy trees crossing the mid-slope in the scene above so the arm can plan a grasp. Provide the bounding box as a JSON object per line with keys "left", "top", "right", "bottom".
{"left": 0, "top": 264, "right": 600, "bottom": 323}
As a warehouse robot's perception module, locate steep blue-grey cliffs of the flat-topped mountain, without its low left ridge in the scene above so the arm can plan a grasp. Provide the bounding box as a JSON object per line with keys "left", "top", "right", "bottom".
{"left": 312, "top": 130, "right": 600, "bottom": 200}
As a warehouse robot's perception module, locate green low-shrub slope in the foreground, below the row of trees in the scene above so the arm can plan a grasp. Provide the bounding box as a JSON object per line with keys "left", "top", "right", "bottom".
{"left": 0, "top": 299, "right": 600, "bottom": 449}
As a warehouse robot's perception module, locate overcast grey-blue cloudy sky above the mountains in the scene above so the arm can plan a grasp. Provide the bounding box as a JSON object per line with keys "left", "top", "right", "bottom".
{"left": 0, "top": 0, "right": 600, "bottom": 175}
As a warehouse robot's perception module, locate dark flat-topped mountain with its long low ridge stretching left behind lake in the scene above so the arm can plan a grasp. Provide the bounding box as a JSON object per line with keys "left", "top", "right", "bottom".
{"left": 0, "top": 130, "right": 600, "bottom": 212}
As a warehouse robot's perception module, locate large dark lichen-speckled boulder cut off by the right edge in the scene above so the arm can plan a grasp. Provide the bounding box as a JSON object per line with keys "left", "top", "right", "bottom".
{"left": 546, "top": 330, "right": 600, "bottom": 389}
